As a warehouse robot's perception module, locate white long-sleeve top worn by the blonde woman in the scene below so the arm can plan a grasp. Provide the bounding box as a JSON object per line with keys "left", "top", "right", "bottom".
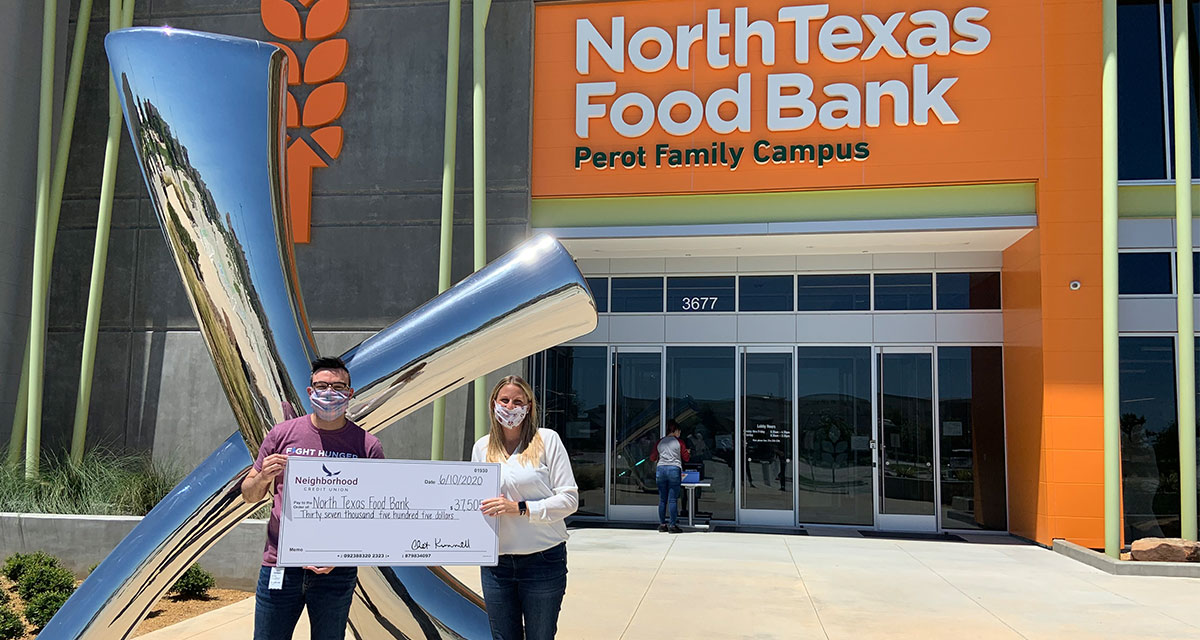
{"left": 470, "top": 429, "right": 580, "bottom": 555}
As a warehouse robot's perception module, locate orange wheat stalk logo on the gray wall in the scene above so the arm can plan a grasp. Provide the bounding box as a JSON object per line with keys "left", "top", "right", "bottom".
{"left": 260, "top": 0, "right": 350, "bottom": 243}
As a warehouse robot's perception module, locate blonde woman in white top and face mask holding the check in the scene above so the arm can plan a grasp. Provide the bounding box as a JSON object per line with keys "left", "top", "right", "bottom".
{"left": 470, "top": 376, "right": 580, "bottom": 640}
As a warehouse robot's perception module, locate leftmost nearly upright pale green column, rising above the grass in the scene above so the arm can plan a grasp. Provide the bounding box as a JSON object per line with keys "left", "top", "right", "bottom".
{"left": 25, "top": 0, "right": 58, "bottom": 478}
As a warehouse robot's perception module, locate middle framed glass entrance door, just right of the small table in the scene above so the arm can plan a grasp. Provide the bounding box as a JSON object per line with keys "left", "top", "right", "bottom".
{"left": 738, "top": 347, "right": 796, "bottom": 526}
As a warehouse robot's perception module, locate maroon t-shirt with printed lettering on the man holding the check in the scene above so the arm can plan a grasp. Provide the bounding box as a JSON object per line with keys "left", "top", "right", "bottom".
{"left": 254, "top": 415, "right": 383, "bottom": 567}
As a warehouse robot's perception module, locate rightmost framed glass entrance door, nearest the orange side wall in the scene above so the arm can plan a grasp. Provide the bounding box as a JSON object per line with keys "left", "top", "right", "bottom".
{"left": 876, "top": 347, "right": 937, "bottom": 531}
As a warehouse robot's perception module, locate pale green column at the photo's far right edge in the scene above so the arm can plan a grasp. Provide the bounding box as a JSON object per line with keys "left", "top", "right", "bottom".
{"left": 1171, "top": 1, "right": 1196, "bottom": 540}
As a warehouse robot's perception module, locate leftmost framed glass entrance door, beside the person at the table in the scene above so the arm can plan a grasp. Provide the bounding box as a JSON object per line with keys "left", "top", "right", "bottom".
{"left": 608, "top": 347, "right": 662, "bottom": 521}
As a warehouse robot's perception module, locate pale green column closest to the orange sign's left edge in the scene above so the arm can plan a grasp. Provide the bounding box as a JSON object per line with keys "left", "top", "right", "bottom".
{"left": 472, "top": 0, "right": 492, "bottom": 438}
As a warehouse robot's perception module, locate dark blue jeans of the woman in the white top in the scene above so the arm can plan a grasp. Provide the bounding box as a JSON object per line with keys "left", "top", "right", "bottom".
{"left": 479, "top": 543, "right": 566, "bottom": 640}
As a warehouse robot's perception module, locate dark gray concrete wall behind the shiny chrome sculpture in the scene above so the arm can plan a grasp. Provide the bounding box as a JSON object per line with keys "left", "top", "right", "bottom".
{"left": 0, "top": 0, "right": 533, "bottom": 469}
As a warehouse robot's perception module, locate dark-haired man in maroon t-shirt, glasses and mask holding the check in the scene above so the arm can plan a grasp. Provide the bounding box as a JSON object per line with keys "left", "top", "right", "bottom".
{"left": 241, "top": 358, "right": 383, "bottom": 640}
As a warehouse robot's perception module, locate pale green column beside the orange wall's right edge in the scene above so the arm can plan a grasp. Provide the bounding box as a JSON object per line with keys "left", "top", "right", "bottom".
{"left": 1100, "top": 0, "right": 1121, "bottom": 557}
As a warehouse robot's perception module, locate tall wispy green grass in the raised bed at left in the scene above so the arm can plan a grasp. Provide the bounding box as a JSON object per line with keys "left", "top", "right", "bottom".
{"left": 0, "top": 449, "right": 182, "bottom": 515}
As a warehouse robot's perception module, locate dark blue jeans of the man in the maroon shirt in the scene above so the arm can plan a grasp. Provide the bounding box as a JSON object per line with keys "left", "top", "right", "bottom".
{"left": 254, "top": 567, "right": 359, "bottom": 640}
